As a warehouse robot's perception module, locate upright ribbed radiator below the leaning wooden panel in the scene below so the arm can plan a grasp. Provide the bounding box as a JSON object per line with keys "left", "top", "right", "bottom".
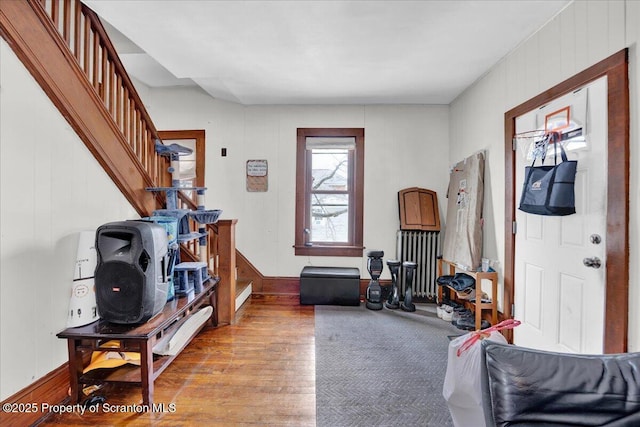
{"left": 396, "top": 230, "right": 440, "bottom": 299}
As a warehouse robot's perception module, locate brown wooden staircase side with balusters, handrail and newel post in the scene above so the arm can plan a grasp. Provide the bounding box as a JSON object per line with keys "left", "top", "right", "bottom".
{"left": 0, "top": 0, "right": 239, "bottom": 324}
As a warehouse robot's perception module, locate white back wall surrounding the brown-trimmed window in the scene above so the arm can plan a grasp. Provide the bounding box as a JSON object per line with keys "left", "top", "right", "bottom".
{"left": 141, "top": 87, "right": 449, "bottom": 277}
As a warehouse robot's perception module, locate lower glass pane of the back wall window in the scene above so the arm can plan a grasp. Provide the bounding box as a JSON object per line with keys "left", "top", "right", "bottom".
{"left": 311, "top": 194, "right": 349, "bottom": 243}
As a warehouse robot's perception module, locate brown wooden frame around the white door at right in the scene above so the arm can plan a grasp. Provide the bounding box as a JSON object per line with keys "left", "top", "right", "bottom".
{"left": 503, "top": 48, "right": 630, "bottom": 353}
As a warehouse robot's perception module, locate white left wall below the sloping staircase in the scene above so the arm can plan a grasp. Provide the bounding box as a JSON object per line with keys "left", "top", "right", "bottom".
{"left": 0, "top": 39, "right": 136, "bottom": 400}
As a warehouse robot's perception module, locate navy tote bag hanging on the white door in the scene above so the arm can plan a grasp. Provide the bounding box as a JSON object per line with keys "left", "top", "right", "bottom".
{"left": 518, "top": 133, "right": 578, "bottom": 216}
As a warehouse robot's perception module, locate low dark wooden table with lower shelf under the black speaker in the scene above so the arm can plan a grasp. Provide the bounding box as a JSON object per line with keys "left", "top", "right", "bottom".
{"left": 57, "top": 279, "right": 218, "bottom": 405}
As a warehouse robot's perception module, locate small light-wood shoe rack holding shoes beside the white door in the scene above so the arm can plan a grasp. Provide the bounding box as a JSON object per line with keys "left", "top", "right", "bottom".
{"left": 438, "top": 259, "right": 498, "bottom": 329}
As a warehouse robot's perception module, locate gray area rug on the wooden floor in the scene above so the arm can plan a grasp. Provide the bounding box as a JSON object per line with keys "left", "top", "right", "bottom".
{"left": 315, "top": 304, "right": 463, "bottom": 427}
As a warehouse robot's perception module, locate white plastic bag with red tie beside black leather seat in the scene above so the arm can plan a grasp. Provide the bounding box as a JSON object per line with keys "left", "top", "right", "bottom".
{"left": 442, "top": 319, "right": 520, "bottom": 427}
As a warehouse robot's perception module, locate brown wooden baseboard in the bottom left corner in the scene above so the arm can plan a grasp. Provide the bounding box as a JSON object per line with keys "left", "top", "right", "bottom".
{"left": 0, "top": 363, "right": 69, "bottom": 427}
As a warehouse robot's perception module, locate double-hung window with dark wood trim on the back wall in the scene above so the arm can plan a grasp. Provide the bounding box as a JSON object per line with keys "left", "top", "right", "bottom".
{"left": 294, "top": 128, "right": 364, "bottom": 257}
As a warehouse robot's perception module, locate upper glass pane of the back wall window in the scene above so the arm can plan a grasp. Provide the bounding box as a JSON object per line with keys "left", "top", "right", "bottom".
{"left": 311, "top": 148, "right": 349, "bottom": 191}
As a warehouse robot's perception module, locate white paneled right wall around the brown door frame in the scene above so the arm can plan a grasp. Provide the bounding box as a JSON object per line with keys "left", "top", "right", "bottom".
{"left": 449, "top": 0, "right": 640, "bottom": 351}
